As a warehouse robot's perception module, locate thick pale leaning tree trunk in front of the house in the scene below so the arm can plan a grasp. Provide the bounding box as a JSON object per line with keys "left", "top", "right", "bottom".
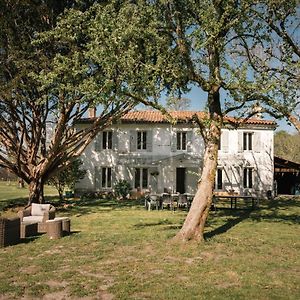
{"left": 175, "top": 124, "right": 220, "bottom": 241}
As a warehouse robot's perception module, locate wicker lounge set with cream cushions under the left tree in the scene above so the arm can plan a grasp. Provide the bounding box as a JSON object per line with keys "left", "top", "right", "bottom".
{"left": 0, "top": 203, "right": 71, "bottom": 247}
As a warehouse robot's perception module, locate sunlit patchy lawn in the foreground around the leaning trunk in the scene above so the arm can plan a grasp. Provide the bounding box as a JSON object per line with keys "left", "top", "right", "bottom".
{"left": 0, "top": 184, "right": 300, "bottom": 299}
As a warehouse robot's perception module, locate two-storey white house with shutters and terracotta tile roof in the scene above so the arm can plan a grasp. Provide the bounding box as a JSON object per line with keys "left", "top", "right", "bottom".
{"left": 77, "top": 111, "right": 275, "bottom": 196}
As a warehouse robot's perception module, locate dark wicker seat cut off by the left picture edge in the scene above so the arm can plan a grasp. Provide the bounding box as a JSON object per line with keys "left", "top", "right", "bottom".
{"left": 0, "top": 217, "right": 20, "bottom": 248}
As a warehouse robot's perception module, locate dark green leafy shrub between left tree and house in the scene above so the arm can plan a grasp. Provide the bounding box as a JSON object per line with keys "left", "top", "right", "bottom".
{"left": 48, "top": 159, "right": 86, "bottom": 200}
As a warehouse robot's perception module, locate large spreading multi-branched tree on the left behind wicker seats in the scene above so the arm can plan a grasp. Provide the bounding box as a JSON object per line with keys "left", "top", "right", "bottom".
{"left": 0, "top": 0, "right": 173, "bottom": 202}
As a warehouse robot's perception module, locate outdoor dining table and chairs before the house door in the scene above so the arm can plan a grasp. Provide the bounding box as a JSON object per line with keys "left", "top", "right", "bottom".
{"left": 145, "top": 193, "right": 194, "bottom": 210}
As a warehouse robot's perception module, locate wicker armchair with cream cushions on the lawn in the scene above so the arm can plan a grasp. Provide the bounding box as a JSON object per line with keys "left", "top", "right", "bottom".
{"left": 18, "top": 203, "right": 55, "bottom": 233}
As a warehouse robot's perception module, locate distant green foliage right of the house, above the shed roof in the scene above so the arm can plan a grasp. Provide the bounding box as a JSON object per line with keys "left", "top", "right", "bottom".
{"left": 274, "top": 131, "right": 300, "bottom": 163}
